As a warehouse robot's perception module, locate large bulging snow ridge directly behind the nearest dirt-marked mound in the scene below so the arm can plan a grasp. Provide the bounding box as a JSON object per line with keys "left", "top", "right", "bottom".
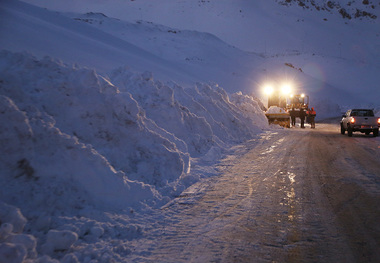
{"left": 2, "top": 53, "right": 188, "bottom": 193}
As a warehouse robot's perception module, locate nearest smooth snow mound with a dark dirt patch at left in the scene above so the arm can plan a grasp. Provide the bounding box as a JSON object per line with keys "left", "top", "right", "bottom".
{"left": 0, "top": 96, "right": 154, "bottom": 209}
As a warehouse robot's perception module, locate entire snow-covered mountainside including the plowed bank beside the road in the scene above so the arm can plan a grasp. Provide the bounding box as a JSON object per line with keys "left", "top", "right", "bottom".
{"left": 0, "top": 0, "right": 380, "bottom": 262}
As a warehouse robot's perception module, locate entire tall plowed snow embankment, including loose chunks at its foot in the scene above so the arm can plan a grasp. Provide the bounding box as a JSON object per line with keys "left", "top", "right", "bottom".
{"left": 0, "top": 51, "right": 267, "bottom": 262}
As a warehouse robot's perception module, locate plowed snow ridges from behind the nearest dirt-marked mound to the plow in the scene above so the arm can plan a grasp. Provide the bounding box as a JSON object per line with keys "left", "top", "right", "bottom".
{"left": 0, "top": 52, "right": 266, "bottom": 196}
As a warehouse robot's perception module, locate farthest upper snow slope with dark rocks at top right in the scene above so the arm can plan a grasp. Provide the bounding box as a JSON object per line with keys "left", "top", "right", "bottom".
{"left": 21, "top": 0, "right": 380, "bottom": 53}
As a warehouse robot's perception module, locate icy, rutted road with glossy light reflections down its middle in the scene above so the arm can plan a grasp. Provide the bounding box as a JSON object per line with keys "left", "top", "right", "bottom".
{"left": 131, "top": 124, "right": 380, "bottom": 262}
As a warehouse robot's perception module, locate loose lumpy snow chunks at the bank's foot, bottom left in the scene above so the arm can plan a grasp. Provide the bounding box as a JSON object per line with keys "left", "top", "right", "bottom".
{"left": 0, "top": 199, "right": 142, "bottom": 263}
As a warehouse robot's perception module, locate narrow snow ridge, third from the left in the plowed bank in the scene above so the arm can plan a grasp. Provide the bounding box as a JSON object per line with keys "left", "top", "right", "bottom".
{"left": 110, "top": 69, "right": 214, "bottom": 156}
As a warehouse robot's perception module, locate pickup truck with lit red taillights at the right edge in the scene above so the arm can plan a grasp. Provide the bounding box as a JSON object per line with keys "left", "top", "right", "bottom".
{"left": 340, "top": 109, "right": 380, "bottom": 137}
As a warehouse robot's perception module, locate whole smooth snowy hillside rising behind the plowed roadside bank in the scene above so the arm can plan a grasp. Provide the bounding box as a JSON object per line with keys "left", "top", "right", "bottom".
{"left": 3, "top": 0, "right": 380, "bottom": 105}
